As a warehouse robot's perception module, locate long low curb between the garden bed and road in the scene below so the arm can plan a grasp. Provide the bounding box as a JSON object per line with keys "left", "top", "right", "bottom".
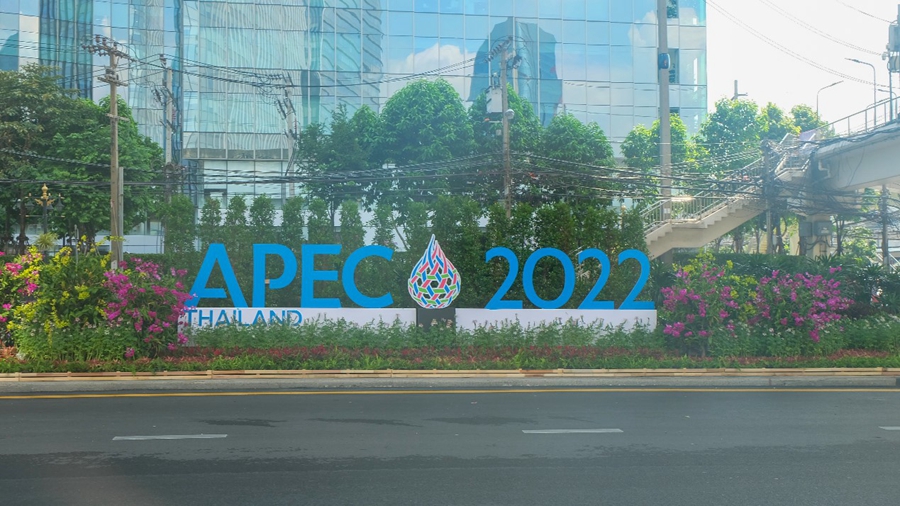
{"left": 0, "top": 368, "right": 900, "bottom": 394}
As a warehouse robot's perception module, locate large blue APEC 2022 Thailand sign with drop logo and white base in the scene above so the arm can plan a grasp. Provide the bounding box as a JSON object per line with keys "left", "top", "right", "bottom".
{"left": 187, "top": 236, "right": 655, "bottom": 326}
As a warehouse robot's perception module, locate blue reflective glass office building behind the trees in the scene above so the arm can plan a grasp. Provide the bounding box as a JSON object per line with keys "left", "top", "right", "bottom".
{"left": 0, "top": 0, "right": 707, "bottom": 204}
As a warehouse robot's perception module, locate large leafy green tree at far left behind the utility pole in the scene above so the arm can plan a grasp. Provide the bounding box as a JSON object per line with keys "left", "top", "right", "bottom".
{"left": 0, "top": 65, "right": 163, "bottom": 247}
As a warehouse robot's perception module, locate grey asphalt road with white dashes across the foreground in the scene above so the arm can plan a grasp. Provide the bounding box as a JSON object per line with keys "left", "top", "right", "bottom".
{"left": 0, "top": 389, "right": 900, "bottom": 506}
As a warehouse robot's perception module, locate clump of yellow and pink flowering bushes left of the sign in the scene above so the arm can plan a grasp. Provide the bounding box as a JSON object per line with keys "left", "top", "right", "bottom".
{"left": 0, "top": 248, "right": 189, "bottom": 360}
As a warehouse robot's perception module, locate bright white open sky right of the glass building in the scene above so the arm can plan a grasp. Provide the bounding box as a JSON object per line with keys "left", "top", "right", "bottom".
{"left": 706, "top": 0, "right": 900, "bottom": 121}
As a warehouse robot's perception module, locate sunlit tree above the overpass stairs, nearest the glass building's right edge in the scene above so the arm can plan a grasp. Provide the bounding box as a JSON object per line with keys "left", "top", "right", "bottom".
{"left": 696, "top": 99, "right": 762, "bottom": 173}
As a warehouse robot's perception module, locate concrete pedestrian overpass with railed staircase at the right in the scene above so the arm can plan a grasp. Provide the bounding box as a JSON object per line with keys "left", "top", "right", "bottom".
{"left": 643, "top": 100, "right": 900, "bottom": 258}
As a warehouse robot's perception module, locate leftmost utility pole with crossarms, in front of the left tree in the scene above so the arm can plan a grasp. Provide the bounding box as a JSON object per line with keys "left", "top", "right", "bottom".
{"left": 84, "top": 35, "right": 128, "bottom": 270}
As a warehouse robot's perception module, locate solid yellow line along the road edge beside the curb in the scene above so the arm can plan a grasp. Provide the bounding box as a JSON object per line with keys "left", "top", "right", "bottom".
{"left": 0, "top": 388, "right": 900, "bottom": 401}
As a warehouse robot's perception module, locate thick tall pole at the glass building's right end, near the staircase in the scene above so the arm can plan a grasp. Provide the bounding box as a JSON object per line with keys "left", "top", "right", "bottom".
{"left": 656, "top": 0, "right": 672, "bottom": 243}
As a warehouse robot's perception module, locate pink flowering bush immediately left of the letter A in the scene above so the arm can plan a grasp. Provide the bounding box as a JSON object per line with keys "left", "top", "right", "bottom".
{"left": 104, "top": 258, "right": 191, "bottom": 358}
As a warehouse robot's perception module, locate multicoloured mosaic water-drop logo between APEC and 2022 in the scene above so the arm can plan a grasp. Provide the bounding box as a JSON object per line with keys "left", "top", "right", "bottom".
{"left": 409, "top": 235, "right": 462, "bottom": 309}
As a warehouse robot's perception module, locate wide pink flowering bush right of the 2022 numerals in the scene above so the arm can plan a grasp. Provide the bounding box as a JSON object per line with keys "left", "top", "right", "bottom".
{"left": 659, "top": 255, "right": 853, "bottom": 355}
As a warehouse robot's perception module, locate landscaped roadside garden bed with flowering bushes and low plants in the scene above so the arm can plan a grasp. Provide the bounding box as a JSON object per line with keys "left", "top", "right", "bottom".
{"left": 0, "top": 250, "right": 900, "bottom": 373}
